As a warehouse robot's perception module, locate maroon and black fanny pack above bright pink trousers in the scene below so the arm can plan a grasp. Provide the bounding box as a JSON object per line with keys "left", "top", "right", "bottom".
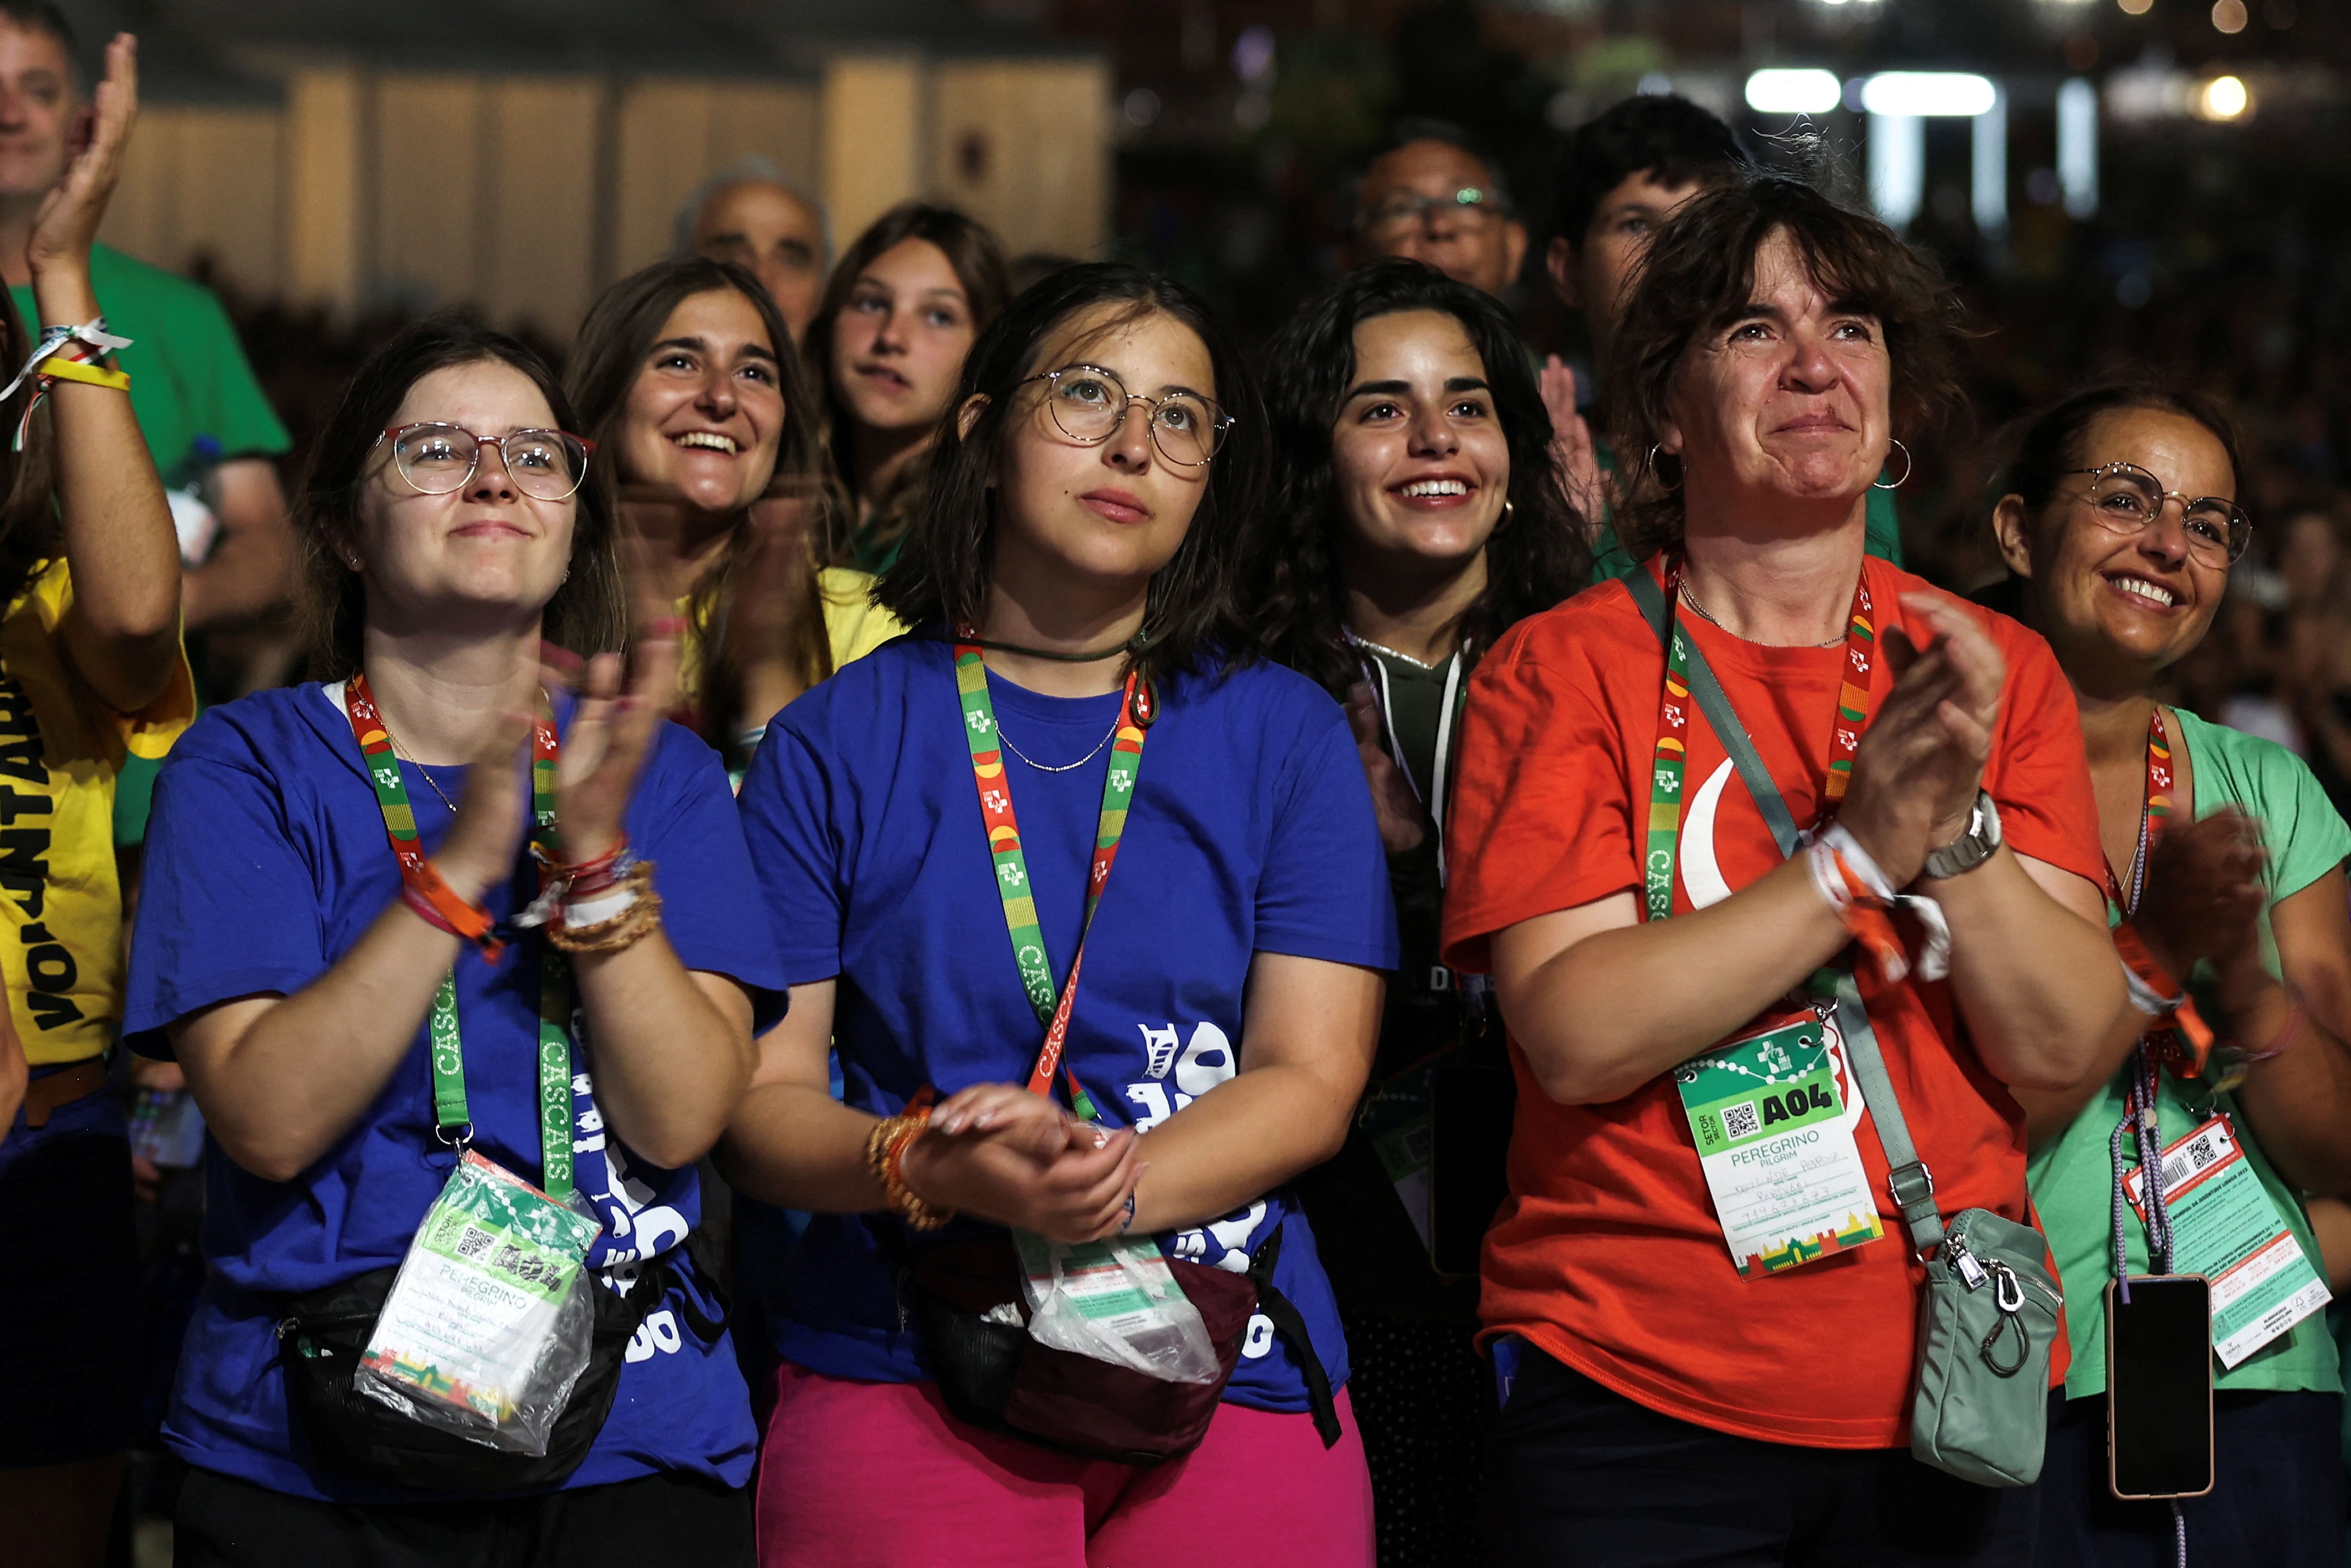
{"left": 872, "top": 1220, "right": 1340, "bottom": 1465}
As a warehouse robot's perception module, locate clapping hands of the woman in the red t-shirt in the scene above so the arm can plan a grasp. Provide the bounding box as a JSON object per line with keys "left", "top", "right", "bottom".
{"left": 1838, "top": 592, "right": 2008, "bottom": 886}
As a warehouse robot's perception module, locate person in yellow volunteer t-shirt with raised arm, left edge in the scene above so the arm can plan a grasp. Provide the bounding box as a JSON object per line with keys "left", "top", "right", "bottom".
{"left": 0, "top": 35, "right": 193, "bottom": 1563}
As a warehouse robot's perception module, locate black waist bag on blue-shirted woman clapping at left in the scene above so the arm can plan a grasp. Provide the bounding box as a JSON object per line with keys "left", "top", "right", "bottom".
{"left": 277, "top": 1232, "right": 726, "bottom": 1493}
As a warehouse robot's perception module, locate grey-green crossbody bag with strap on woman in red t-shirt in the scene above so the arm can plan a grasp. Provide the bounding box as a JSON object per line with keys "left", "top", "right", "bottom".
{"left": 1625, "top": 569, "right": 2064, "bottom": 1486}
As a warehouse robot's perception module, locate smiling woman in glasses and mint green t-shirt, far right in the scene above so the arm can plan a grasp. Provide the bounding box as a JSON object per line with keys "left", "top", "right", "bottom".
{"left": 1994, "top": 386, "right": 2351, "bottom": 1568}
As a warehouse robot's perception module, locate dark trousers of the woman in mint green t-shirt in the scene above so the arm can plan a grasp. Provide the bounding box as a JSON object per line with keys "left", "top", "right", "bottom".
{"left": 2034, "top": 1394, "right": 2344, "bottom": 1568}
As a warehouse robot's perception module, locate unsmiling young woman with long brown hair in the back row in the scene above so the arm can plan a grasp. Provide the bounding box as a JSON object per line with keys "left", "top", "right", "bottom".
{"left": 806, "top": 202, "right": 1013, "bottom": 574}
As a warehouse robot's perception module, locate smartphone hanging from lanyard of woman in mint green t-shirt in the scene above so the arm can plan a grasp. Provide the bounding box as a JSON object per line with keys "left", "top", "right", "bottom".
{"left": 2106, "top": 1274, "right": 2212, "bottom": 1497}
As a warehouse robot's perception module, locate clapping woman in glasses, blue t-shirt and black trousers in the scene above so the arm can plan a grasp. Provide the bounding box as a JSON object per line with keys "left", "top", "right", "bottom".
{"left": 125, "top": 320, "right": 778, "bottom": 1568}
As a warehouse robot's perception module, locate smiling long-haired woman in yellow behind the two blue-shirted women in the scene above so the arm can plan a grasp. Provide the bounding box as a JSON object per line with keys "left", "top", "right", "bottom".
{"left": 567, "top": 256, "right": 905, "bottom": 769}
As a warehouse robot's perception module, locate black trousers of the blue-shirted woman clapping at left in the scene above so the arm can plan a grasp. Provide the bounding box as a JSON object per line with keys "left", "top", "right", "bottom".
{"left": 174, "top": 1469, "right": 755, "bottom": 1568}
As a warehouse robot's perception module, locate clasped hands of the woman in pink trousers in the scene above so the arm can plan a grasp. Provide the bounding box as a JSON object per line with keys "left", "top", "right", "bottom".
{"left": 900, "top": 1084, "right": 1150, "bottom": 1241}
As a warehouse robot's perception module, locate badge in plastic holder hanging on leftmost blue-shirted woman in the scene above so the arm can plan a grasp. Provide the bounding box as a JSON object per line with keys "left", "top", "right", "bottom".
{"left": 355, "top": 1150, "right": 604, "bottom": 1455}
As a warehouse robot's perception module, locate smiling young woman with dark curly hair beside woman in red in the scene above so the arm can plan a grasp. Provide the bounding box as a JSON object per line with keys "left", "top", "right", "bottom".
{"left": 1248, "top": 261, "right": 1589, "bottom": 1563}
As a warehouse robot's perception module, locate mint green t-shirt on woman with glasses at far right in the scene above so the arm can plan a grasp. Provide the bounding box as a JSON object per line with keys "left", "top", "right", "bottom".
{"left": 2027, "top": 710, "right": 2351, "bottom": 1399}
